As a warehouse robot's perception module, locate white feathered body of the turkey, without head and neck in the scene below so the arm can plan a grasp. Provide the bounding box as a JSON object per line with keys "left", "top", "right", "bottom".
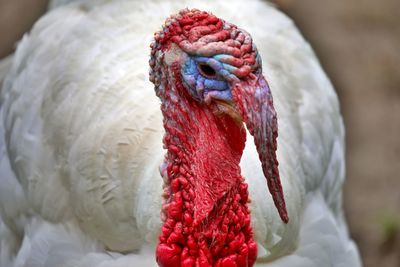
{"left": 0, "top": 0, "right": 361, "bottom": 267}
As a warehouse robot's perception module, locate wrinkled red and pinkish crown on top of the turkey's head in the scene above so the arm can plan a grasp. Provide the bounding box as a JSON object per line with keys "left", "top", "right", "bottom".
{"left": 149, "top": 9, "right": 261, "bottom": 98}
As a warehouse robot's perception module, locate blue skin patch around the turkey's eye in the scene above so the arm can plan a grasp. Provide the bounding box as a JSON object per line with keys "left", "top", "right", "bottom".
{"left": 181, "top": 55, "right": 237, "bottom": 102}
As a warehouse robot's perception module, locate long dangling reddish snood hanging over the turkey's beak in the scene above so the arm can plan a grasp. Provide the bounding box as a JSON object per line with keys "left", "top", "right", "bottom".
{"left": 232, "top": 74, "right": 289, "bottom": 223}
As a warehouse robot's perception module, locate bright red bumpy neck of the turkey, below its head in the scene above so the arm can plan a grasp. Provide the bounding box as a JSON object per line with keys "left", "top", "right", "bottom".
{"left": 156, "top": 63, "right": 257, "bottom": 267}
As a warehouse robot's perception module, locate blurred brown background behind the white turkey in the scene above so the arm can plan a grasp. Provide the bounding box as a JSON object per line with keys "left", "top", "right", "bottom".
{"left": 0, "top": 0, "right": 400, "bottom": 267}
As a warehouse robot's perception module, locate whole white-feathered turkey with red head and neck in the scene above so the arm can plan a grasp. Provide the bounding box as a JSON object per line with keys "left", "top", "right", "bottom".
{"left": 0, "top": 0, "right": 361, "bottom": 267}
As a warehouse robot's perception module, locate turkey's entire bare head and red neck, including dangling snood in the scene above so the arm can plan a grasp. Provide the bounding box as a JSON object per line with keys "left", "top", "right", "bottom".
{"left": 150, "top": 9, "right": 288, "bottom": 267}
